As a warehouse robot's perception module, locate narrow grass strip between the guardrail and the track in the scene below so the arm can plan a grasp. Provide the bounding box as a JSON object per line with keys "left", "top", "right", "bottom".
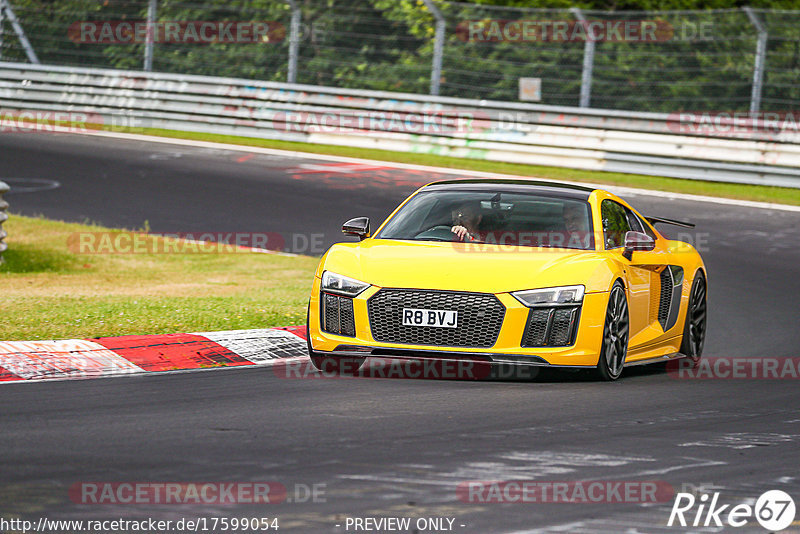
{"left": 117, "top": 128, "right": 800, "bottom": 205}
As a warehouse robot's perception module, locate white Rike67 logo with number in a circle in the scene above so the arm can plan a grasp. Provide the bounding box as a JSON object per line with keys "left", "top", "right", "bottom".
{"left": 667, "top": 490, "right": 795, "bottom": 532}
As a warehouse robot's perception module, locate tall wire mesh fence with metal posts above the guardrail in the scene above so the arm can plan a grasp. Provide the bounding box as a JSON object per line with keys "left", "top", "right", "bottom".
{"left": 0, "top": 0, "right": 800, "bottom": 112}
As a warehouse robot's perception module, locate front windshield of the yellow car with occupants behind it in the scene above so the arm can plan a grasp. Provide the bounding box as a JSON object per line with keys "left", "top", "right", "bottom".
{"left": 375, "top": 190, "right": 594, "bottom": 250}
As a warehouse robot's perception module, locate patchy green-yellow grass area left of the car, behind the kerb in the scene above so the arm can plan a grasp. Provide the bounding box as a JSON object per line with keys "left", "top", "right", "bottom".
{"left": 0, "top": 214, "right": 318, "bottom": 341}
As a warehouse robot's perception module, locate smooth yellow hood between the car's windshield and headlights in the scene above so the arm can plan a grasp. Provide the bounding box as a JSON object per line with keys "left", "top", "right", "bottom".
{"left": 317, "top": 239, "right": 610, "bottom": 293}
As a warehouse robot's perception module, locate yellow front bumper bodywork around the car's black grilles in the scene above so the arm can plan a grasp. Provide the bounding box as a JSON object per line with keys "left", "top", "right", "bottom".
{"left": 308, "top": 277, "right": 608, "bottom": 367}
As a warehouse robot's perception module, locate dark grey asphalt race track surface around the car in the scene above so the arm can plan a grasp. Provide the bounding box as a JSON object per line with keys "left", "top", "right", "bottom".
{"left": 0, "top": 134, "right": 800, "bottom": 533}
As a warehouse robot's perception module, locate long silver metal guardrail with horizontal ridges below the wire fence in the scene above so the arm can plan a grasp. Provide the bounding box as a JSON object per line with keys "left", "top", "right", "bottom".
{"left": 0, "top": 62, "right": 800, "bottom": 188}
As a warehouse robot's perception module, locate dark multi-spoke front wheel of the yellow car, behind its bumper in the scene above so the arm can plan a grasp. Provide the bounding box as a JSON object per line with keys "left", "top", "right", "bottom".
{"left": 595, "top": 281, "right": 630, "bottom": 381}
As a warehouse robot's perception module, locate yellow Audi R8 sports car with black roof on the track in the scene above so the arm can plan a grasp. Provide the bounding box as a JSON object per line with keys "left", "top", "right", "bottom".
{"left": 307, "top": 179, "right": 707, "bottom": 380}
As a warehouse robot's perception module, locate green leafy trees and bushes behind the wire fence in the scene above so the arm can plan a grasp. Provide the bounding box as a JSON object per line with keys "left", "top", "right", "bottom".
{"left": 2, "top": 0, "right": 800, "bottom": 112}
